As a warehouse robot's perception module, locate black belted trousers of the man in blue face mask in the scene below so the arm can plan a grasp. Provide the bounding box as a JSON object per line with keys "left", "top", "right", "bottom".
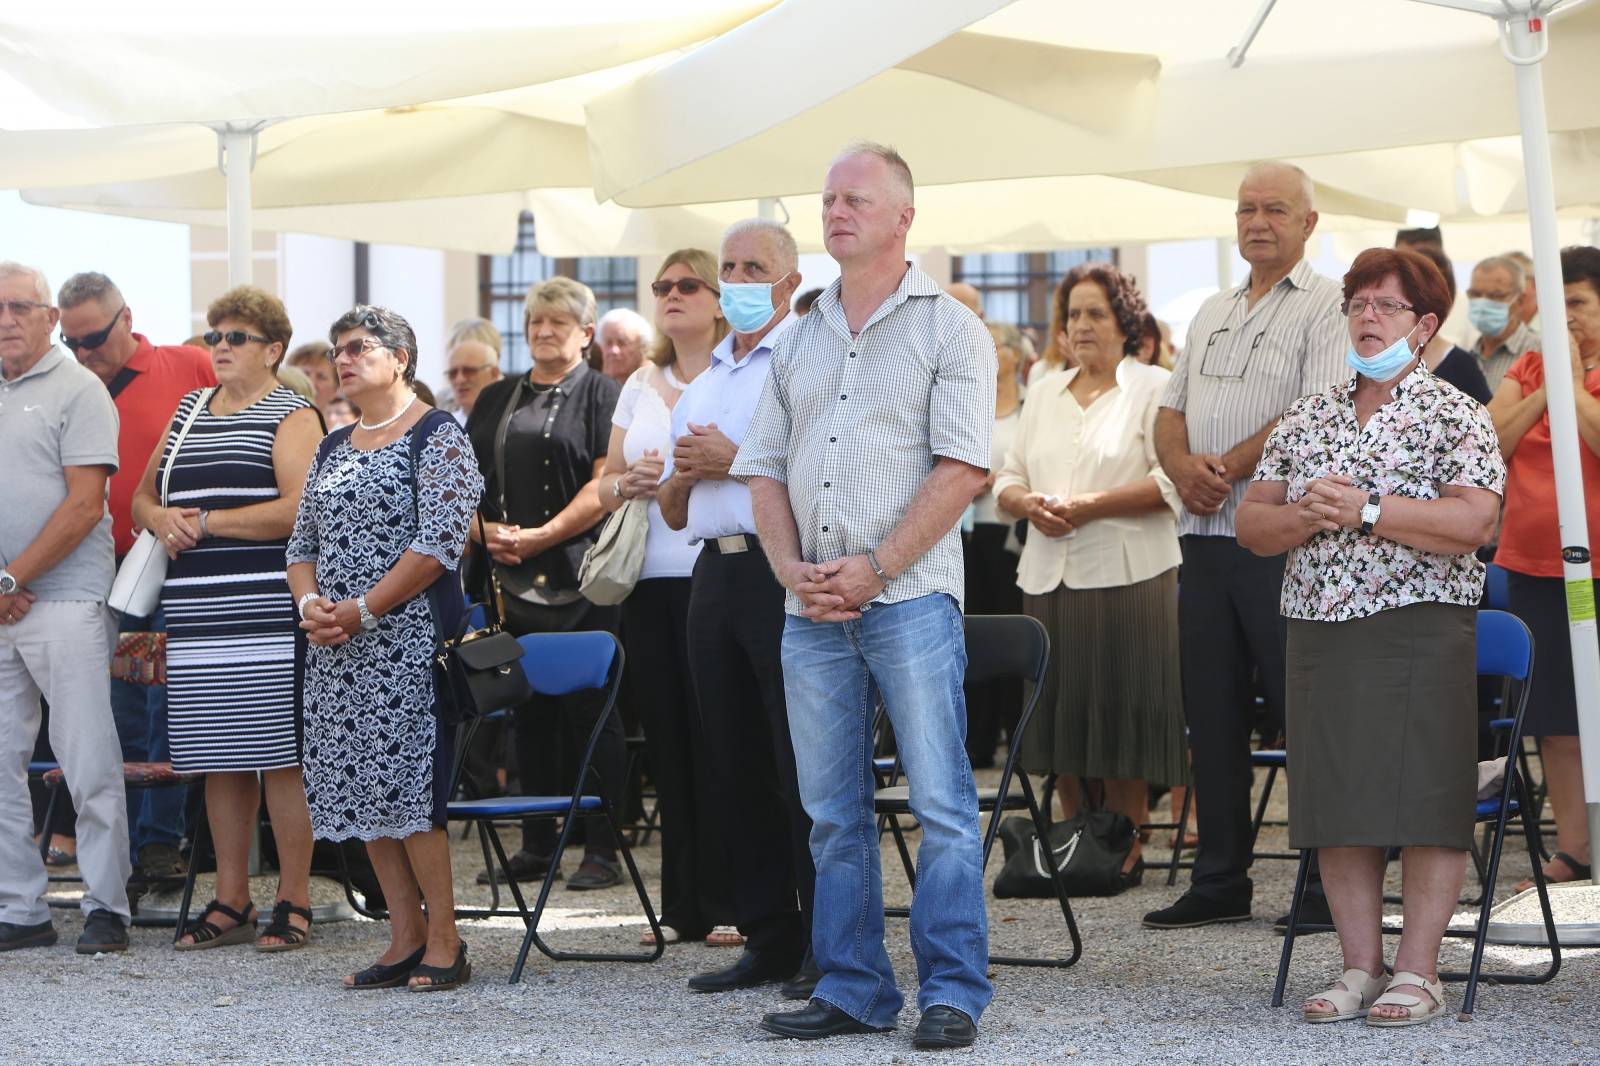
{"left": 690, "top": 547, "right": 816, "bottom": 964}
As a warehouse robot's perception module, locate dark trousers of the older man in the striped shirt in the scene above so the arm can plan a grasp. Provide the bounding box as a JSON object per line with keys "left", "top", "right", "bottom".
{"left": 1178, "top": 536, "right": 1286, "bottom": 906}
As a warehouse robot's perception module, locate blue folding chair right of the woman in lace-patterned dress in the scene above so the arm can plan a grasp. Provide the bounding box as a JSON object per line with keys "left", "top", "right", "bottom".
{"left": 448, "top": 632, "right": 666, "bottom": 984}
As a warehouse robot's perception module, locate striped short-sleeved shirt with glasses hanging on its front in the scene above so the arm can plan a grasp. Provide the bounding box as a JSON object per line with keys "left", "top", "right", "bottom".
{"left": 1162, "top": 259, "right": 1350, "bottom": 536}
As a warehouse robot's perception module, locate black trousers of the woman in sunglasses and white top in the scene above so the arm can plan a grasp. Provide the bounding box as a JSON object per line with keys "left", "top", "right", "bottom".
{"left": 622, "top": 578, "right": 733, "bottom": 940}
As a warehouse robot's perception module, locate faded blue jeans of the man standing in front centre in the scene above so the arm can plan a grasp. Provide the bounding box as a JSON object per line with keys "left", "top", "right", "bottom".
{"left": 784, "top": 594, "right": 994, "bottom": 1026}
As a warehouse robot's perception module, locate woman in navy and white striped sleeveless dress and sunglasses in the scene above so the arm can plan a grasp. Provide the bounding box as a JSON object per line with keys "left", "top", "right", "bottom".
{"left": 133, "top": 285, "right": 322, "bottom": 951}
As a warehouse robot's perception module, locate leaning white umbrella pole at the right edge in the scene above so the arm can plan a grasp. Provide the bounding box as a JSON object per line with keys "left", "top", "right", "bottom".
{"left": 1502, "top": 10, "right": 1600, "bottom": 857}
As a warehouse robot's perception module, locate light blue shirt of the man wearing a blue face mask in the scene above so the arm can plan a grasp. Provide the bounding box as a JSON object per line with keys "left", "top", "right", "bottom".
{"left": 662, "top": 312, "right": 800, "bottom": 544}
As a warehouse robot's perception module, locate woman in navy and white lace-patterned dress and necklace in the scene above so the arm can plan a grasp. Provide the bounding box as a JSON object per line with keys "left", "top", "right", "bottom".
{"left": 288, "top": 307, "right": 483, "bottom": 991}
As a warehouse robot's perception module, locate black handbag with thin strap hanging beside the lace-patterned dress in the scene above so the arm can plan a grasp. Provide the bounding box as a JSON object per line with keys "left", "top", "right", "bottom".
{"left": 410, "top": 406, "right": 533, "bottom": 725}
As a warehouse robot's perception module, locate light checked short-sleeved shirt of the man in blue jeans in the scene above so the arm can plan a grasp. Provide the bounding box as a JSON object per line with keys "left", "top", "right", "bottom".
{"left": 731, "top": 266, "right": 995, "bottom": 615}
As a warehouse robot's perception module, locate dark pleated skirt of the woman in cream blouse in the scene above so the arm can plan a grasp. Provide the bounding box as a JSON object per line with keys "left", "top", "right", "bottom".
{"left": 1022, "top": 567, "right": 1189, "bottom": 784}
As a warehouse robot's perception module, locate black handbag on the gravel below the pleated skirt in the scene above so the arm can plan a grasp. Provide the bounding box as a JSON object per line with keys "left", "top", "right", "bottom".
{"left": 994, "top": 810, "right": 1136, "bottom": 900}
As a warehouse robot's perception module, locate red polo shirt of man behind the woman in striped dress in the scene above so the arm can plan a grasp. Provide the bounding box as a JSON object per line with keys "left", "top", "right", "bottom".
{"left": 110, "top": 333, "right": 216, "bottom": 559}
